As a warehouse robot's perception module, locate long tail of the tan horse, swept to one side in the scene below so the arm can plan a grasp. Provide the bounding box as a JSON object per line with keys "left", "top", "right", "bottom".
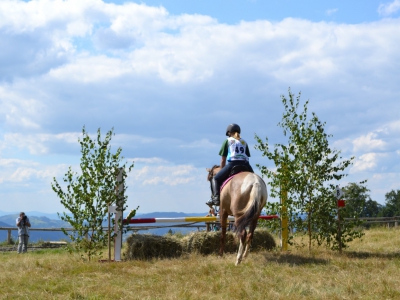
{"left": 234, "top": 182, "right": 266, "bottom": 235}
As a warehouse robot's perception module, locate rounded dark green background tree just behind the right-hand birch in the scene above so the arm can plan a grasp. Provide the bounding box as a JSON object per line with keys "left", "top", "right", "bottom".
{"left": 341, "top": 181, "right": 383, "bottom": 218}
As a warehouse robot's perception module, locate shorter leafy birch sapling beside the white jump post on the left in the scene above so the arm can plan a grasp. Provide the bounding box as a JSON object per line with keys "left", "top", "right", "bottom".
{"left": 52, "top": 127, "right": 133, "bottom": 260}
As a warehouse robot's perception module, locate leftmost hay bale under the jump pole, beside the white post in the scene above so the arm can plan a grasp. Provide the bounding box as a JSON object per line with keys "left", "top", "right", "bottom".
{"left": 124, "top": 234, "right": 182, "bottom": 260}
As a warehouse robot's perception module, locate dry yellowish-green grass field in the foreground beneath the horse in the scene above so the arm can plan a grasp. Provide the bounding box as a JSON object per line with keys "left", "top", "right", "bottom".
{"left": 0, "top": 228, "right": 400, "bottom": 299}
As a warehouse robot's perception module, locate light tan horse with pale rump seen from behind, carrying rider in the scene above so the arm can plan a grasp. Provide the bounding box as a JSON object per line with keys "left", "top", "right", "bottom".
{"left": 206, "top": 165, "right": 268, "bottom": 266}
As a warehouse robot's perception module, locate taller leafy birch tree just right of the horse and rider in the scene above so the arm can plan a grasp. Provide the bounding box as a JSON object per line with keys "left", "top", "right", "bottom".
{"left": 255, "top": 89, "right": 361, "bottom": 250}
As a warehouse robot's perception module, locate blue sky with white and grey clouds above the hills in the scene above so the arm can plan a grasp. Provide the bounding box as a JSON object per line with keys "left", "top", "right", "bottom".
{"left": 0, "top": 0, "right": 400, "bottom": 213}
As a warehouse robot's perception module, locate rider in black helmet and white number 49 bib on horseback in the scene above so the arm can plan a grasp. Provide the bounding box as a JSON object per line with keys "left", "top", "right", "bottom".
{"left": 206, "top": 124, "right": 253, "bottom": 207}
